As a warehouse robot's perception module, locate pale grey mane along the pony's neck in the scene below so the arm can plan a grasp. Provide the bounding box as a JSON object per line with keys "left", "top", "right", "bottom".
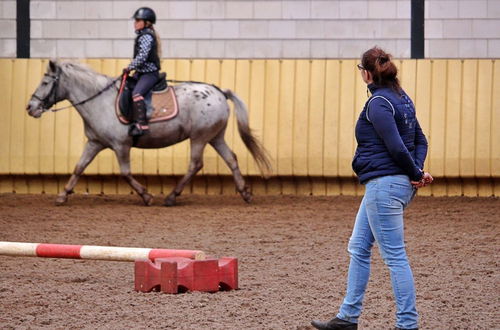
{"left": 59, "top": 61, "right": 112, "bottom": 93}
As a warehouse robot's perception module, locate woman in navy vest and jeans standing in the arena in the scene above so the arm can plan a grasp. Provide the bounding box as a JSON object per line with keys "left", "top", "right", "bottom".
{"left": 311, "top": 47, "right": 433, "bottom": 330}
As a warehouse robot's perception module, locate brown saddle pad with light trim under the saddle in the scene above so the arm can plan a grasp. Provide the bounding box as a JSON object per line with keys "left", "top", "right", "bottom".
{"left": 115, "top": 86, "right": 179, "bottom": 125}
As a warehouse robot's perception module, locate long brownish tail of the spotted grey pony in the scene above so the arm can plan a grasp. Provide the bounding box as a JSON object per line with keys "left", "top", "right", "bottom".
{"left": 222, "top": 89, "right": 272, "bottom": 177}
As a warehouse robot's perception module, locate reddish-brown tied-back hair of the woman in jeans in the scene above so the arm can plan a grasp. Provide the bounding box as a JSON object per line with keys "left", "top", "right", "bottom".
{"left": 361, "top": 47, "right": 401, "bottom": 93}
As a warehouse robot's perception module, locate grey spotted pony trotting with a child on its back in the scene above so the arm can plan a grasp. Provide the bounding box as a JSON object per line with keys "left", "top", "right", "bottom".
{"left": 26, "top": 61, "right": 270, "bottom": 206}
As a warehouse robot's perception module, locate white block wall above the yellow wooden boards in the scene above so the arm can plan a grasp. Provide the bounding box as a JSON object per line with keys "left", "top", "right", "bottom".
{"left": 0, "top": 0, "right": 500, "bottom": 58}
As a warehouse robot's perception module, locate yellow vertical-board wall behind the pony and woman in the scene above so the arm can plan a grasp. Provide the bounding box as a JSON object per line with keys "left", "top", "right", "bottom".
{"left": 0, "top": 59, "right": 500, "bottom": 196}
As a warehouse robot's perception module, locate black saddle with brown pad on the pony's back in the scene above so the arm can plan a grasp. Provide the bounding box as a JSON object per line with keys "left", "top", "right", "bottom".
{"left": 115, "top": 72, "right": 179, "bottom": 125}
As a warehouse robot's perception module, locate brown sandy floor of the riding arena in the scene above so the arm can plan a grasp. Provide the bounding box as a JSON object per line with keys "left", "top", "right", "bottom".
{"left": 0, "top": 194, "right": 500, "bottom": 329}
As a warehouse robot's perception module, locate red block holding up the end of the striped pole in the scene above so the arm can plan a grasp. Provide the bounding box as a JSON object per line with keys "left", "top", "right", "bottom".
{"left": 135, "top": 257, "right": 238, "bottom": 293}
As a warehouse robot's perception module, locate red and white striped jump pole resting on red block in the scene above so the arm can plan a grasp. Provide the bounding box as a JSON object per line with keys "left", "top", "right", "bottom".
{"left": 0, "top": 242, "right": 205, "bottom": 261}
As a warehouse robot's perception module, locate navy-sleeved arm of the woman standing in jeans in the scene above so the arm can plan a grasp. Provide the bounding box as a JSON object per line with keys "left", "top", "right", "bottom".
{"left": 367, "top": 98, "right": 423, "bottom": 181}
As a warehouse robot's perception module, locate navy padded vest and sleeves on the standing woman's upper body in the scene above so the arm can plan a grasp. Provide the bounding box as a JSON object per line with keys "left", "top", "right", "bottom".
{"left": 352, "top": 84, "right": 427, "bottom": 183}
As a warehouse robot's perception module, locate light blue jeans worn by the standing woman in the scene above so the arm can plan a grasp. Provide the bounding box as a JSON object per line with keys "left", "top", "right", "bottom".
{"left": 337, "top": 175, "right": 418, "bottom": 329}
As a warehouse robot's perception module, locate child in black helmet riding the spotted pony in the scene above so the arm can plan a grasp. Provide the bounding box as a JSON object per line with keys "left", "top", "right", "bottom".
{"left": 123, "top": 7, "right": 161, "bottom": 136}
